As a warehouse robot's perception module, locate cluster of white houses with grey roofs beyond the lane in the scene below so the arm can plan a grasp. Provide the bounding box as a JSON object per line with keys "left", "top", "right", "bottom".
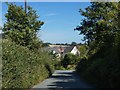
{"left": 44, "top": 45, "right": 80, "bottom": 58}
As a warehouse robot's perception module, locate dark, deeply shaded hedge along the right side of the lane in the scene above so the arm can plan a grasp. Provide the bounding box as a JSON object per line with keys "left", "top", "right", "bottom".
{"left": 76, "top": 43, "right": 120, "bottom": 88}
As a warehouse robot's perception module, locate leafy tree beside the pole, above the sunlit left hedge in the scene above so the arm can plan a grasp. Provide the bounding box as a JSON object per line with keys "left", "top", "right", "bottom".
{"left": 3, "top": 3, "right": 44, "bottom": 47}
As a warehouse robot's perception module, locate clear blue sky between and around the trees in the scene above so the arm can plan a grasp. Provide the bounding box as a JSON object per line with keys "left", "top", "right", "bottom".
{"left": 2, "top": 2, "right": 90, "bottom": 43}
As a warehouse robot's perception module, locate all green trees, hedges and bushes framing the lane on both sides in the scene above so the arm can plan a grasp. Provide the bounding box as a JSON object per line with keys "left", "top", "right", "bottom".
{"left": 2, "top": 2, "right": 120, "bottom": 88}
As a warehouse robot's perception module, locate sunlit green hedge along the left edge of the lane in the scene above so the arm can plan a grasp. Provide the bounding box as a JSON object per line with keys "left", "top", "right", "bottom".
{"left": 2, "top": 39, "right": 54, "bottom": 88}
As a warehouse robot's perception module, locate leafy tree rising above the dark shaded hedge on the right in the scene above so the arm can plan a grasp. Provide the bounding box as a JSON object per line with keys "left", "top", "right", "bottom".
{"left": 75, "top": 2, "right": 118, "bottom": 47}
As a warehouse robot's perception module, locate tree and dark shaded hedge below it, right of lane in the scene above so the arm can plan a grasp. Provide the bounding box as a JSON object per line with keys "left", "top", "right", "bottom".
{"left": 75, "top": 2, "right": 120, "bottom": 88}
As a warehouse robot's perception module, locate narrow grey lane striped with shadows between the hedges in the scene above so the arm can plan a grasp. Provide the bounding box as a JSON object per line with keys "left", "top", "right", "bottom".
{"left": 33, "top": 70, "right": 92, "bottom": 89}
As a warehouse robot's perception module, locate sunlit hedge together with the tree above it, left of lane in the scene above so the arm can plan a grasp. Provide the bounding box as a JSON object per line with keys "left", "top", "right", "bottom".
{"left": 2, "top": 3, "right": 55, "bottom": 89}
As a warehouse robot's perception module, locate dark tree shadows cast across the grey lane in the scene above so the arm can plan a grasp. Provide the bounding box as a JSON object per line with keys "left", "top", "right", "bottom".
{"left": 47, "top": 71, "right": 92, "bottom": 89}
